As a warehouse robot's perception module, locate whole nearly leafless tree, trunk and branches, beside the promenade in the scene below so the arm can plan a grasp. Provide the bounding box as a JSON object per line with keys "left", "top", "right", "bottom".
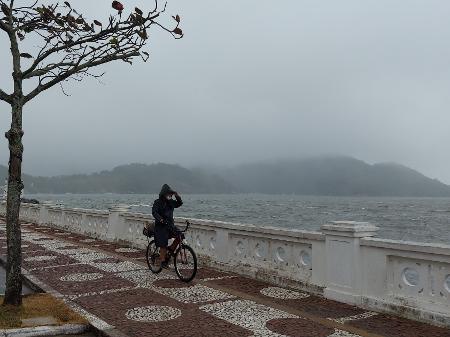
{"left": 0, "top": 0, "right": 183, "bottom": 305}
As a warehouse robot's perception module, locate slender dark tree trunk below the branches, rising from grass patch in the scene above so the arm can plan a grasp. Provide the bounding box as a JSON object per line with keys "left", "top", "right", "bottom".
{"left": 3, "top": 99, "right": 23, "bottom": 305}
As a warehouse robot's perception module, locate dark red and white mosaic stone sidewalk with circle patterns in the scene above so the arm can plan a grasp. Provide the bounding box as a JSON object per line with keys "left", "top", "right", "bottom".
{"left": 0, "top": 222, "right": 450, "bottom": 337}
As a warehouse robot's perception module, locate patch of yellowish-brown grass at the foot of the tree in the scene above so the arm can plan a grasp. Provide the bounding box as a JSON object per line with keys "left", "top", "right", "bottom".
{"left": 0, "top": 294, "right": 87, "bottom": 329}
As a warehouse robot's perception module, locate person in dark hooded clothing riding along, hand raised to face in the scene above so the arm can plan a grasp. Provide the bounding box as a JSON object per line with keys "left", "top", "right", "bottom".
{"left": 152, "top": 184, "right": 183, "bottom": 268}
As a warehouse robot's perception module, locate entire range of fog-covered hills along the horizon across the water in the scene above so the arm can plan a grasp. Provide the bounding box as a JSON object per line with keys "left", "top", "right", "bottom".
{"left": 0, "top": 157, "right": 450, "bottom": 197}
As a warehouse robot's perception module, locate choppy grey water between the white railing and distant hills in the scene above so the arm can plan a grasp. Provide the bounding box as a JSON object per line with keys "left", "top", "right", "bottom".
{"left": 27, "top": 194, "right": 450, "bottom": 244}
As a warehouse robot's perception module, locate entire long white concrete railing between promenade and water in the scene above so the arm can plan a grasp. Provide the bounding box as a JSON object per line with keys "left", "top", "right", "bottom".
{"left": 0, "top": 200, "right": 450, "bottom": 326}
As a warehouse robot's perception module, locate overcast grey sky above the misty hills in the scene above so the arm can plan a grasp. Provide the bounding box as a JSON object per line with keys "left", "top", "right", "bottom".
{"left": 0, "top": 0, "right": 450, "bottom": 183}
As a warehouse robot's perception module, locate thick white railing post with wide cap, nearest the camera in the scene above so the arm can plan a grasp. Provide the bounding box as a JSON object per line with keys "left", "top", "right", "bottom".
{"left": 322, "top": 221, "right": 378, "bottom": 305}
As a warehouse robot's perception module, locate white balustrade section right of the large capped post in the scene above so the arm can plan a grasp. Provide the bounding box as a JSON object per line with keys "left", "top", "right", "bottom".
{"left": 361, "top": 238, "right": 450, "bottom": 326}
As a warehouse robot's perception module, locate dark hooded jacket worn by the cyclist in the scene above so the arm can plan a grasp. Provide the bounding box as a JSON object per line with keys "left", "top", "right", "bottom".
{"left": 152, "top": 184, "right": 183, "bottom": 226}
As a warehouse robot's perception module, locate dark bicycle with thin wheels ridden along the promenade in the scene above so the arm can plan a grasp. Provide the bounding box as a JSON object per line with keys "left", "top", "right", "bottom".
{"left": 144, "top": 221, "right": 197, "bottom": 282}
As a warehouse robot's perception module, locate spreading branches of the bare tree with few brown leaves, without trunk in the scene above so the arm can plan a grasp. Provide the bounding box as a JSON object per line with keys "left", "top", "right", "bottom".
{"left": 6, "top": 0, "right": 183, "bottom": 104}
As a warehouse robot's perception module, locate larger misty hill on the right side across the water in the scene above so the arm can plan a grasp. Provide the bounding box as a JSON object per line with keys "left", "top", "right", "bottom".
{"left": 222, "top": 157, "right": 450, "bottom": 197}
